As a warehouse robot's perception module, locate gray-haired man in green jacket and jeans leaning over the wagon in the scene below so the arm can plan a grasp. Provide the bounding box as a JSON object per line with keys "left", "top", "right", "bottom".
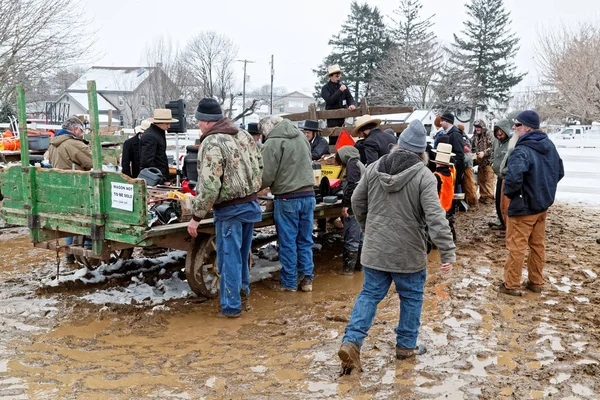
{"left": 258, "top": 116, "right": 315, "bottom": 292}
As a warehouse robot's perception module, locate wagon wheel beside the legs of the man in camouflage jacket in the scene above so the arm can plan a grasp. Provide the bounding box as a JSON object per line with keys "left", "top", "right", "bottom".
{"left": 185, "top": 235, "right": 221, "bottom": 299}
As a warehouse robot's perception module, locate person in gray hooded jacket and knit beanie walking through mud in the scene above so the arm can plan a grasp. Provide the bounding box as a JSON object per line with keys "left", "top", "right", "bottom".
{"left": 338, "top": 120, "right": 456, "bottom": 374}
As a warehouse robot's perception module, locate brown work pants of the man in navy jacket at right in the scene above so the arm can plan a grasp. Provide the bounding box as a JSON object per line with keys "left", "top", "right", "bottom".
{"left": 504, "top": 211, "right": 548, "bottom": 289}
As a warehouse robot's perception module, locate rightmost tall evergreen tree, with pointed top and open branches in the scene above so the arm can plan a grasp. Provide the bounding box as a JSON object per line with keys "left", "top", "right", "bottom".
{"left": 453, "top": 0, "right": 524, "bottom": 122}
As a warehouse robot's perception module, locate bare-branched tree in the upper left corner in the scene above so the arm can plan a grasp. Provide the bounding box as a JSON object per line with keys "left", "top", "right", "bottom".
{"left": 0, "top": 0, "right": 92, "bottom": 102}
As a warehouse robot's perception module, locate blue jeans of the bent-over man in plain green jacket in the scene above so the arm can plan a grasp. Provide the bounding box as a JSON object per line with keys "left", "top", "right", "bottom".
{"left": 274, "top": 196, "right": 316, "bottom": 289}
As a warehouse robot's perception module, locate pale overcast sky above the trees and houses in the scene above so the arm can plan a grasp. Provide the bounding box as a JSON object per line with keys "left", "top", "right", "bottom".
{"left": 82, "top": 0, "right": 600, "bottom": 94}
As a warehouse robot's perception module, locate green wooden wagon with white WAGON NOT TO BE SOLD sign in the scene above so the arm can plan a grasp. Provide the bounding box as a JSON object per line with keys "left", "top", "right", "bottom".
{"left": 0, "top": 81, "right": 341, "bottom": 298}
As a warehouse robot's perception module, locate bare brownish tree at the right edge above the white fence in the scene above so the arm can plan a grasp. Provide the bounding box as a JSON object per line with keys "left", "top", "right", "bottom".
{"left": 536, "top": 23, "right": 600, "bottom": 123}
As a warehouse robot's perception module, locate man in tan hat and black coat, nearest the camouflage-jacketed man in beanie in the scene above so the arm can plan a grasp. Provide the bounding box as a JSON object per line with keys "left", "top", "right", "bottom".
{"left": 140, "top": 108, "right": 179, "bottom": 181}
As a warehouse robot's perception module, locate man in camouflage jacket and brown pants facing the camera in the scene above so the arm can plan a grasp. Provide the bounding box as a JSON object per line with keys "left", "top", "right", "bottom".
{"left": 472, "top": 120, "right": 496, "bottom": 203}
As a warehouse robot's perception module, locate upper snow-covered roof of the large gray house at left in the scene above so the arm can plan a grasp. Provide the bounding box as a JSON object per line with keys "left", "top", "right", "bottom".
{"left": 67, "top": 67, "right": 155, "bottom": 92}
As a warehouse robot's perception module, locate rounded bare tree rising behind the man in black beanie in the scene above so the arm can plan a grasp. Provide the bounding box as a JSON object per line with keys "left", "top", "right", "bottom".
{"left": 184, "top": 31, "right": 238, "bottom": 105}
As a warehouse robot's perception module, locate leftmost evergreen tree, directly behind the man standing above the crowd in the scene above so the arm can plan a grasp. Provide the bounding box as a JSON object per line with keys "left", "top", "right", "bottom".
{"left": 315, "top": 1, "right": 392, "bottom": 101}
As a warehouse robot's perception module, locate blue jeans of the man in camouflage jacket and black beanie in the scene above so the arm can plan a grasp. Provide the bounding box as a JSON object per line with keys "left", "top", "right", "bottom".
{"left": 214, "top": 201, "right": 262, "bottom": 315}
